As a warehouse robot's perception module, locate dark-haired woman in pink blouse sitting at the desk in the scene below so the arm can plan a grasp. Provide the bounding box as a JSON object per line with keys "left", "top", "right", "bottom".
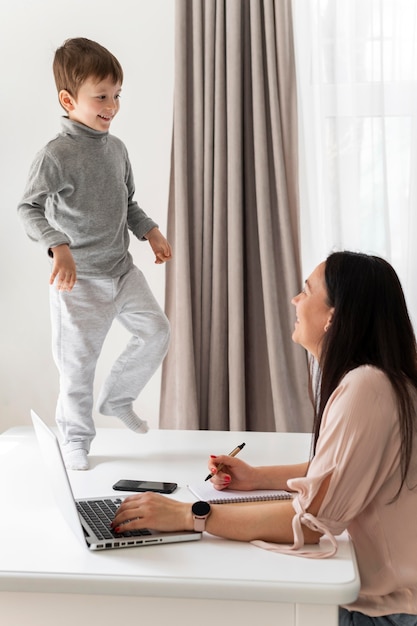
{"left": 113, "top": 252, "right": 417, "bottom": 626}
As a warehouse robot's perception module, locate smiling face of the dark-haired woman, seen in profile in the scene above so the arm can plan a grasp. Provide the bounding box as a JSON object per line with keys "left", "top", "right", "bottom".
{"left": 291, "top": 262, "right": 334, "bottom": 359}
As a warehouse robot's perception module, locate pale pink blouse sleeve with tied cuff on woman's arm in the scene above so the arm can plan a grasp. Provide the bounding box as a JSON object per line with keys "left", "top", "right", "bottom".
{"left": 250, "top": 366, "right": 400, "bottom": 558}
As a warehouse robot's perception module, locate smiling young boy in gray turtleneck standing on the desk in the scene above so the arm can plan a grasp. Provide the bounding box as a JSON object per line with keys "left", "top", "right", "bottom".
{"left": 18, "top": 38, "right": 171, "bottom": 470}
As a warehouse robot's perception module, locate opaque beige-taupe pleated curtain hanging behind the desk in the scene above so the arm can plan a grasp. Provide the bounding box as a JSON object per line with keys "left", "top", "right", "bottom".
{"left": 160, "top": 0, "right": 312, "bottom": 431}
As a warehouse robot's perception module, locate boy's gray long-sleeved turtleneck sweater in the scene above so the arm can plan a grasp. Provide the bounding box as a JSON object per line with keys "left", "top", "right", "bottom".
{"left": 18, "top": 117, "right": 157, "bottom": 278}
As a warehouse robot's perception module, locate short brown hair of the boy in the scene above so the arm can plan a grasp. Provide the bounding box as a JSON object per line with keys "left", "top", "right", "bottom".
{"left": 52, "top": 37, "right": 123, "bottom": 98}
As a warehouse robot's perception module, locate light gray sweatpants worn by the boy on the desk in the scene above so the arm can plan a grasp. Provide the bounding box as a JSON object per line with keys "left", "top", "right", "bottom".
{"left": 50, "top": 267, "right": 170, "bottom": 452}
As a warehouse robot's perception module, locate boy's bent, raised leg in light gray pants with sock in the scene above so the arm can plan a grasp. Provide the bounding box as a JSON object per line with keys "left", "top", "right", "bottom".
{"left": 97, "top": 267, "right": 170, "bottom": 432}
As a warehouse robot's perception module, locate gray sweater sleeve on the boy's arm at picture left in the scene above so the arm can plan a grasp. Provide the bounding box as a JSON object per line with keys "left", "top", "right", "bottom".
{"left": 17, "top": 149, "right": 71, "bottom": 251}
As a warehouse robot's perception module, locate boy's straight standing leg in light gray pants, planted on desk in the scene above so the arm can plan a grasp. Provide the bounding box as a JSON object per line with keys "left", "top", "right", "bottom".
{"left": 50, "top": 279, "right": 114, "bottom": 469}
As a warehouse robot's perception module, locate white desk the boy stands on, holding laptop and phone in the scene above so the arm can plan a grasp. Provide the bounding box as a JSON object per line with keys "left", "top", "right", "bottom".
{"left": 0, "top": 427, "right": 359, "bottom": 626}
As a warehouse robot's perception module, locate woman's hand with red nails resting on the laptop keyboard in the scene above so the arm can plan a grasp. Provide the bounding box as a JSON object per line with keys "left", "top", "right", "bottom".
{"left": 112, "top": 492, "right": 194, "bottom": 533}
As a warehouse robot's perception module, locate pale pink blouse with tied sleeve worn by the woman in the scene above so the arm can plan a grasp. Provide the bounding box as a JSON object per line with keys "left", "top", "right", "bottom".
{"left": 254, "top": 366, "right": 417, "bottom": 616}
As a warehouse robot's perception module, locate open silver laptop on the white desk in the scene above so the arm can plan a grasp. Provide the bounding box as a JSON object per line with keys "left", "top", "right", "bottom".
{"left": 30, "top": 411, "right": 202, "bottom": 550}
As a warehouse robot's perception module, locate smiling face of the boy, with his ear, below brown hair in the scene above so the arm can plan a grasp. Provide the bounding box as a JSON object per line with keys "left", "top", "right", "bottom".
{"left": 59, "top": 77, "right": 122, "bottom": 131}
